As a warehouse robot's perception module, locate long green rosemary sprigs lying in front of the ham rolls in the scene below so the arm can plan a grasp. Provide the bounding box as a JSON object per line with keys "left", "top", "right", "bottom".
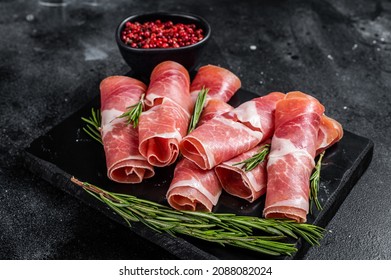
{"left": 71, "top": 177, "right": 323, "bottom": 256}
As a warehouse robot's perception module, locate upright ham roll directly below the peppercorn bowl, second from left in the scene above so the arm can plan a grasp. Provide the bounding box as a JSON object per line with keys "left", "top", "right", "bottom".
{"left": 139, "top": 61, "right": 193, "bottom": 167}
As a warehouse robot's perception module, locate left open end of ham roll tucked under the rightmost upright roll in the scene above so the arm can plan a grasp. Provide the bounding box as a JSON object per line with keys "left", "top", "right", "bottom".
{"left": 215, "top": 139, "right": 270, "bottom": 202}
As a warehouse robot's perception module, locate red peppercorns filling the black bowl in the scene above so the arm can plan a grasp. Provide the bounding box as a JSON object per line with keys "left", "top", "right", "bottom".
{"left": 121, "top": 20, "right": 204, "bottom": 49}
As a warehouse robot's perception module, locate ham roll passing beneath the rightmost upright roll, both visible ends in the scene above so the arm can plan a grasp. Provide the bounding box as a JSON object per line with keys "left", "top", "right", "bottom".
{"left": 215, "top": 115, "right": 343, "bottom": 202}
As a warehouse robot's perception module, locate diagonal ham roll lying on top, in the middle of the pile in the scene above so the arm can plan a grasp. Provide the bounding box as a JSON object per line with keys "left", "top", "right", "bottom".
{"left": 179, "top": 92, "right": 285, "bottom": 170}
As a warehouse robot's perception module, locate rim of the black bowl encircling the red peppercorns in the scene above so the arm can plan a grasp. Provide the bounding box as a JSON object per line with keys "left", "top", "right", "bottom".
{"left": 115, "top": 12, "right": 212, "bottom": 53}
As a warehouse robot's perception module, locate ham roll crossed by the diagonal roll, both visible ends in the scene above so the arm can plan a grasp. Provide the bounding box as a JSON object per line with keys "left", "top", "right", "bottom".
{"left": 166, "top": 65, "right": 240, "bottom": 212}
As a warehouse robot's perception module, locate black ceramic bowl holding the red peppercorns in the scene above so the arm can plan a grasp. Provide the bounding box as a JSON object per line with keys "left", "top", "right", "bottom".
{"left": 115, "top": 12, "right": 211, "bottom": 78}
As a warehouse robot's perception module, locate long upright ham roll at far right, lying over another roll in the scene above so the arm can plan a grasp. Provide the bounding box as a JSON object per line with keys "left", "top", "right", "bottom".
{"left": 263, "top": 91, "right": 324, "bottom": 223}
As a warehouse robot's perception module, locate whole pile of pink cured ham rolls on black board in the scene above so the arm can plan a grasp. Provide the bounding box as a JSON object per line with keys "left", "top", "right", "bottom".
{"left": 100, "top": 61, "right": 343, "bottom": 223}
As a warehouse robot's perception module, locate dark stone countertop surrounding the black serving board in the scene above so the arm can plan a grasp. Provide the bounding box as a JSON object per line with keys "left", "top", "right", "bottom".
{"left": 0, "top": 0, "right": 391, "bottom": 259}
